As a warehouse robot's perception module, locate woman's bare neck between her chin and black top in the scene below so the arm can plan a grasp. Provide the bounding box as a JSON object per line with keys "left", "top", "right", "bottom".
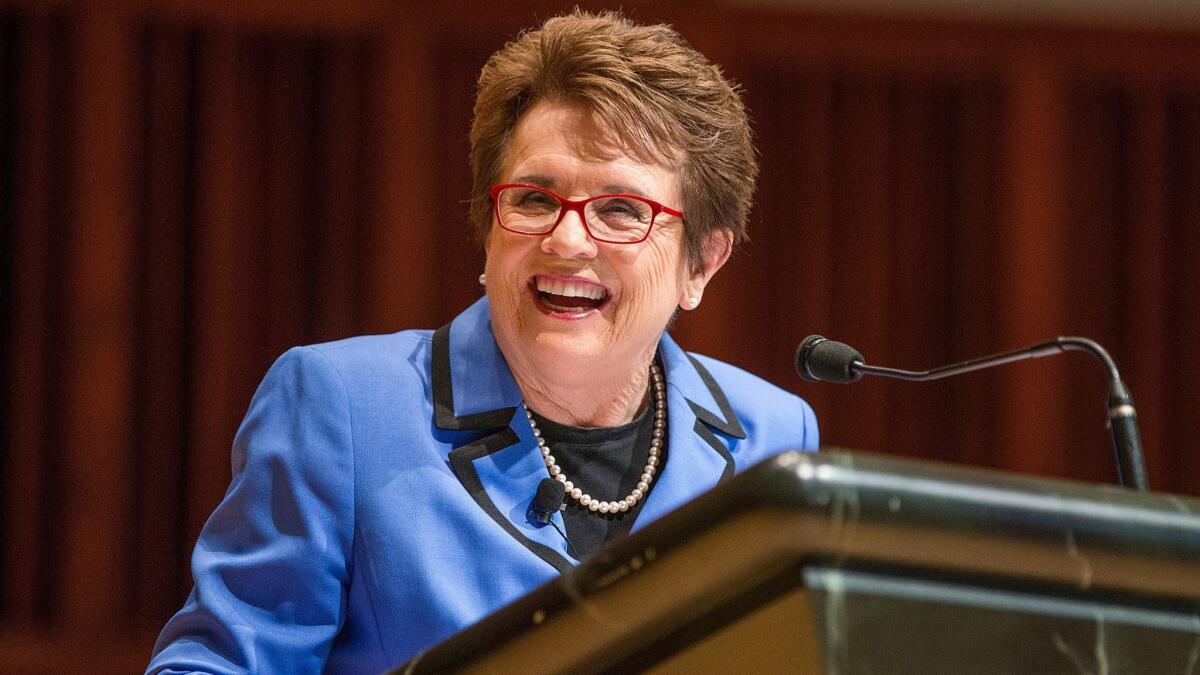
{"left": 512, "top": 352, "right": 654, "bottom": 426}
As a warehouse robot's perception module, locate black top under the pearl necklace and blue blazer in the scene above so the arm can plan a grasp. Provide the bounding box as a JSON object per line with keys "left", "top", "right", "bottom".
{"left": 530, "top": 406, "right": 667, "bottom": 558}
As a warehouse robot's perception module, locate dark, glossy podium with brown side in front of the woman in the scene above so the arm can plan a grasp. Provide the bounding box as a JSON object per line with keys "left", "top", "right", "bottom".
{"left": 394, "top": 452, "right": 1200, "bottom": 675}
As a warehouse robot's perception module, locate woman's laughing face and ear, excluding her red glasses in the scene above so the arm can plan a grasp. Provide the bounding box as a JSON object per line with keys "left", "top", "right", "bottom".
{"left": 486, "top": 101, "right": 727, "bottom": 382}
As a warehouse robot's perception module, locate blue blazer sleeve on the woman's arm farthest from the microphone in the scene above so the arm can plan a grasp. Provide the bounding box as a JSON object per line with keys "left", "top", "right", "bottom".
{"left": 146, "top": 347, "right": 354, "bottom": 673}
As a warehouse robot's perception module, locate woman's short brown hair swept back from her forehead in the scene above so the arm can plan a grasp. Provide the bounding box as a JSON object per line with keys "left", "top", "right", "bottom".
{"left": 470, "top": 10, "right": 758, "bottom": 267}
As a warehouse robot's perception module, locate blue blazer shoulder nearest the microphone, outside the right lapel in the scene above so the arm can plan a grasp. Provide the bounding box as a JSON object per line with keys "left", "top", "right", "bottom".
{"left": 688, "top": 352, "right": 818, "bottom": 449}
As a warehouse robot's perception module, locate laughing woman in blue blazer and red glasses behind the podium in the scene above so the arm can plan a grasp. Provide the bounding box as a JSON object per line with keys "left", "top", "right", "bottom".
{"left": 142, "top": 13, "right": 817, "bottom": 673}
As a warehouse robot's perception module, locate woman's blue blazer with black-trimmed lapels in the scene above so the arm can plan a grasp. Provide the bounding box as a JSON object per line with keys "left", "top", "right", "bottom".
{"left": 148, "top": 299, "right": 817, "bottom": 673}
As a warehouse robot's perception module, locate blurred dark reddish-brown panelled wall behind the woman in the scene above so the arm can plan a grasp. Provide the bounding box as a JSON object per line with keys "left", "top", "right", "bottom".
{"left": 0, "top": 0, "right": 1200, "bottom": 673}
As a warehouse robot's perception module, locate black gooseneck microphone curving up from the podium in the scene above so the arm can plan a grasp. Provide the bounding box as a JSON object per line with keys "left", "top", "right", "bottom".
{"left": 796, "top": 335, "right": 1147, "bottom": 490}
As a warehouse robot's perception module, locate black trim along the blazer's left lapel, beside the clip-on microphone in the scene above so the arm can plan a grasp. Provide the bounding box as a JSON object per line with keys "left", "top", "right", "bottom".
{"left": 430, "top": 317, "right": 575, "bottom": 573}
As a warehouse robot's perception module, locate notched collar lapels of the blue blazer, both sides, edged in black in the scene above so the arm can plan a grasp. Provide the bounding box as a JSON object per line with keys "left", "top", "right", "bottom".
{"left": 431, "top": 298, "right": 745, "bottom": 564}
